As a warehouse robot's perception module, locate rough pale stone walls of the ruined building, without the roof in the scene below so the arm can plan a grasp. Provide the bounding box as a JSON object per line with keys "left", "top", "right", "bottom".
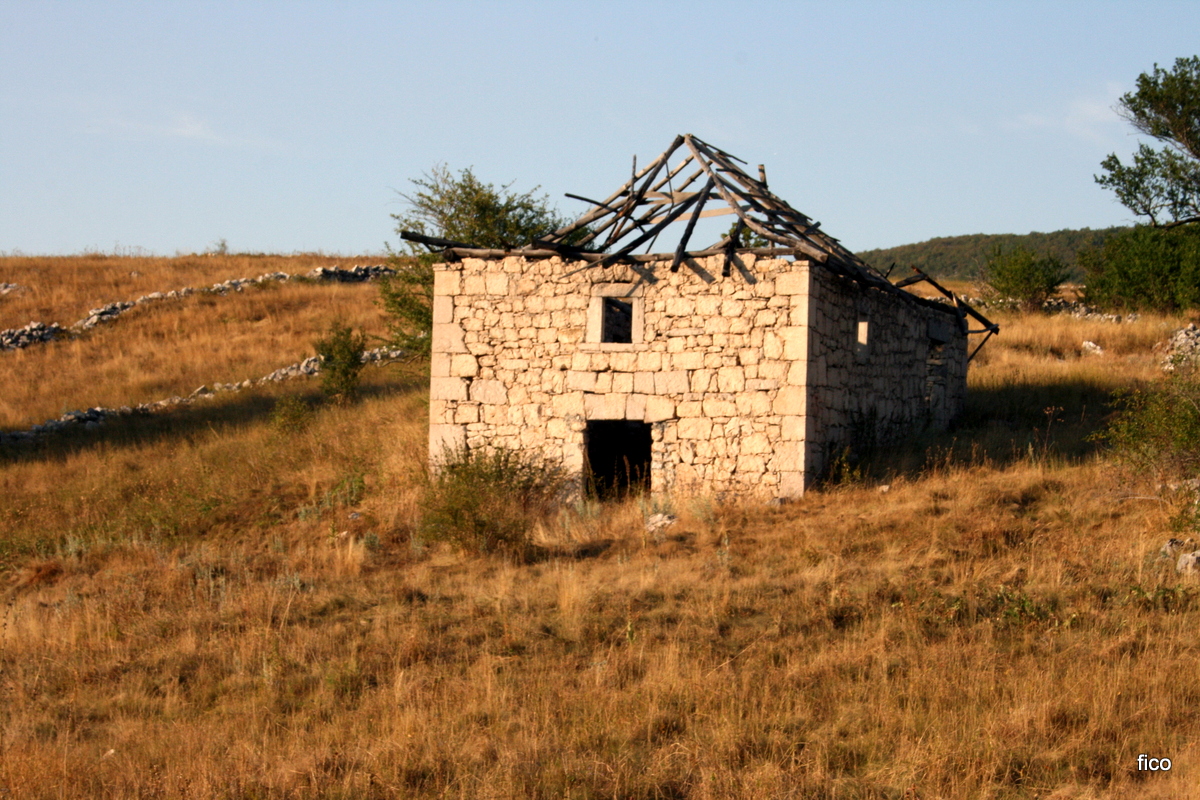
{"left": 430, "top": 255, "right": 965, "bottom": 495}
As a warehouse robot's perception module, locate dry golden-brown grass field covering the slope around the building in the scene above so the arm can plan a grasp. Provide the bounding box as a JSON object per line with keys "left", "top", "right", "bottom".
{"left": 0, "top": 259, "right": 1200, "bottom": 800}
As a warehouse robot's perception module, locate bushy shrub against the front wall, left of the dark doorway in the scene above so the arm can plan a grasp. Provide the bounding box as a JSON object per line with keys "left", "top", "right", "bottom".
{"left": 420, "top": 450, "right": 568, "bottom": 555}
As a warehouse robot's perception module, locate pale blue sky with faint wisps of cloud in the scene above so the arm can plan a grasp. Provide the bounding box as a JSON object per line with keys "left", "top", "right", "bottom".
{"left": 0, "top": 0, "right": 1200, "bottom": 256}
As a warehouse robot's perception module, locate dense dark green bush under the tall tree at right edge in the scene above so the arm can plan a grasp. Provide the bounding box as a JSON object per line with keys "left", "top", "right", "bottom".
{"left": 1079, "top": 225, "right": 1200, "bottom": 311}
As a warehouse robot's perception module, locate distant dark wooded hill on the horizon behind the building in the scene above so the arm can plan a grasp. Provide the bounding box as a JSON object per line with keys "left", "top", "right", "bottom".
{"left": 858, "top": 227, "right": 1126, "bottom": 279}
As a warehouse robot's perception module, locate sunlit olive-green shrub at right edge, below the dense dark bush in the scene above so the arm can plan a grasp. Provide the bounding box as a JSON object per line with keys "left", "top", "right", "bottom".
{"left": 1099, "top": 373, "right": 1200, "bottom": 479}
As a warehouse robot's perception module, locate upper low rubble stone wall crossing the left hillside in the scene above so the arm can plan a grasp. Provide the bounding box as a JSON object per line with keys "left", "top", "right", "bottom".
{"left": 0, "top": 264, "right": 396, "bottom": 350}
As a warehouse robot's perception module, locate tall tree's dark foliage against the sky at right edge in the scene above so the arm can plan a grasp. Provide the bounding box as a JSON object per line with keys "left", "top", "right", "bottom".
{"left": 1096, "top": 56, "right": 1200, "bottom": 228}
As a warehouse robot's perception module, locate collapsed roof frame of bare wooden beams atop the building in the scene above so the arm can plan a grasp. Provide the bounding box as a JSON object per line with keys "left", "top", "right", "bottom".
{"left": 401, "top": 133, "right": 1000, "bottom": 356}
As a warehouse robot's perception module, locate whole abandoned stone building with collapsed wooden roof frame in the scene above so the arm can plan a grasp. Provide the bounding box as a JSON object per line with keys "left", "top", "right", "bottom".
{"left": 404, "top": 136, "right": 998, "bottom": 498}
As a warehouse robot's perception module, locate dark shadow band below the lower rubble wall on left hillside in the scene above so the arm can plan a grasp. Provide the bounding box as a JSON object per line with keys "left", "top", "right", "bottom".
{"left": 0, "top": 371, "right": 428, "bottom": 464}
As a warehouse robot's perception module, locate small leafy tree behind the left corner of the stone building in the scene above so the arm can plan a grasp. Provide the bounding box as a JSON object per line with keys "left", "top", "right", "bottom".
{"left": 379, "top": 164, "right": 587, "bottom": 356}
